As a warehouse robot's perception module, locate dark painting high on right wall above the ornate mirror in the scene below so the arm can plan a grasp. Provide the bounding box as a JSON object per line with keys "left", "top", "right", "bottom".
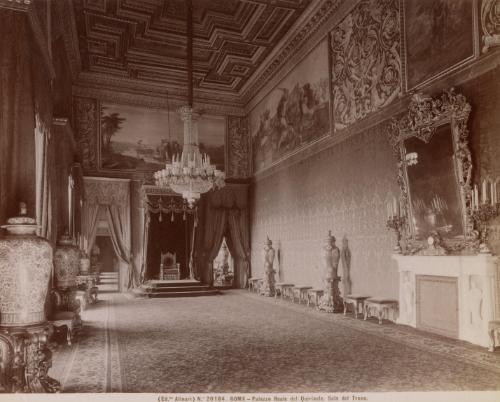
{"left": 404, "top": 0, "right": 475, "bottom": 90}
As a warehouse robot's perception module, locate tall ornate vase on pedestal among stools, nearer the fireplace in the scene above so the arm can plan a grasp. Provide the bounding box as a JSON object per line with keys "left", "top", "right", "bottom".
{"left": 319, "top": 231, "right": 343, "bottom": 313}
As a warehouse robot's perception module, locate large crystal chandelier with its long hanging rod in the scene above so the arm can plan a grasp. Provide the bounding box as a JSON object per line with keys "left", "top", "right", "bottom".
{"left": 154, "top": 0, "right": 225, "bottom": 207}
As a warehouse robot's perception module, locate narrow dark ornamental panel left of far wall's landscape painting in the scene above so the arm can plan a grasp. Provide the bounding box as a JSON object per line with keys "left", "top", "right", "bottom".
{"left": 74, "top": 97, "right": 98, "bottom": 170}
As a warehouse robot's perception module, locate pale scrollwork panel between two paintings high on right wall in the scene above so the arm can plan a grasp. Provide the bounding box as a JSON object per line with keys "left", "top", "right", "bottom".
{"left": 330, "top": 0, "right": 402, "bottom": 131}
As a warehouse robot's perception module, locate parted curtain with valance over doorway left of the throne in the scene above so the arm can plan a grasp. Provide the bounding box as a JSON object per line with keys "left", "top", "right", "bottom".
{"left": 82, "top": 177, "right": 139, "bottom": 290}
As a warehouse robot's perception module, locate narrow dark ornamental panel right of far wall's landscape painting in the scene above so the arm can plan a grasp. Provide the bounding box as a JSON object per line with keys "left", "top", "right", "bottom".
{"left": 226, "top": 116, "right": 251, "bottom": 178}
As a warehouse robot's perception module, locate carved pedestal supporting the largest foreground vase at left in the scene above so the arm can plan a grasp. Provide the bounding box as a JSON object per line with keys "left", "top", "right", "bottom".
{"left": 0, "top": 322, "right": 61, "bottom": 393}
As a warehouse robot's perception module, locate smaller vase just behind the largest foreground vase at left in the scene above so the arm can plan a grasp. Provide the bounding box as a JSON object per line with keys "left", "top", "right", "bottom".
{"left": 54, "top": 235, "right": 80, "bottom": 289}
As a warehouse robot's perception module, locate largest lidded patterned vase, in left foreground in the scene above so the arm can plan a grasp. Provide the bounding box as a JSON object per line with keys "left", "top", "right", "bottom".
{"left": 0, "top": 203, "right": 52, "bottom": 327}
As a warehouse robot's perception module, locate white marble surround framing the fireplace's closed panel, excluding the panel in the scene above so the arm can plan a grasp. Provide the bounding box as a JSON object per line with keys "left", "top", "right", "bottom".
{"left": 393, "top": 254, "right": 500, "bottom": 346}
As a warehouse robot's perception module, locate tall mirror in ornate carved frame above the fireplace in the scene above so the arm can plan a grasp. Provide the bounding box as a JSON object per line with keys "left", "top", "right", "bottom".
{"left": 389, "top": 89, "right": 477, "bottom": 254}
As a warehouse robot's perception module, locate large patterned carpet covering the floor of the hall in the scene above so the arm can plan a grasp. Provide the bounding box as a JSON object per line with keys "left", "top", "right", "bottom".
{"left": 50, "top": 290, "right": 500, "bottom": 393}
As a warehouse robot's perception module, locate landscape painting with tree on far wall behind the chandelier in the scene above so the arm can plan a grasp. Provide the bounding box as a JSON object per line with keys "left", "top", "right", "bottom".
{"left": 99, "top": 103, "right": 226, "bottom": 172}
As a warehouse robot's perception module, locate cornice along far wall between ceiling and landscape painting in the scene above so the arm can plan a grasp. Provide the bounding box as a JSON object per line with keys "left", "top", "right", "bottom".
{"left": 73, "top": 85, "right": 244, "bottom": 116}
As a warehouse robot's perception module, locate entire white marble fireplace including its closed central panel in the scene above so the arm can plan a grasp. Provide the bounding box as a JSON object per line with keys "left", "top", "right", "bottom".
{"left": 393, "top": 254, "right": 500, "bottom": 347}
